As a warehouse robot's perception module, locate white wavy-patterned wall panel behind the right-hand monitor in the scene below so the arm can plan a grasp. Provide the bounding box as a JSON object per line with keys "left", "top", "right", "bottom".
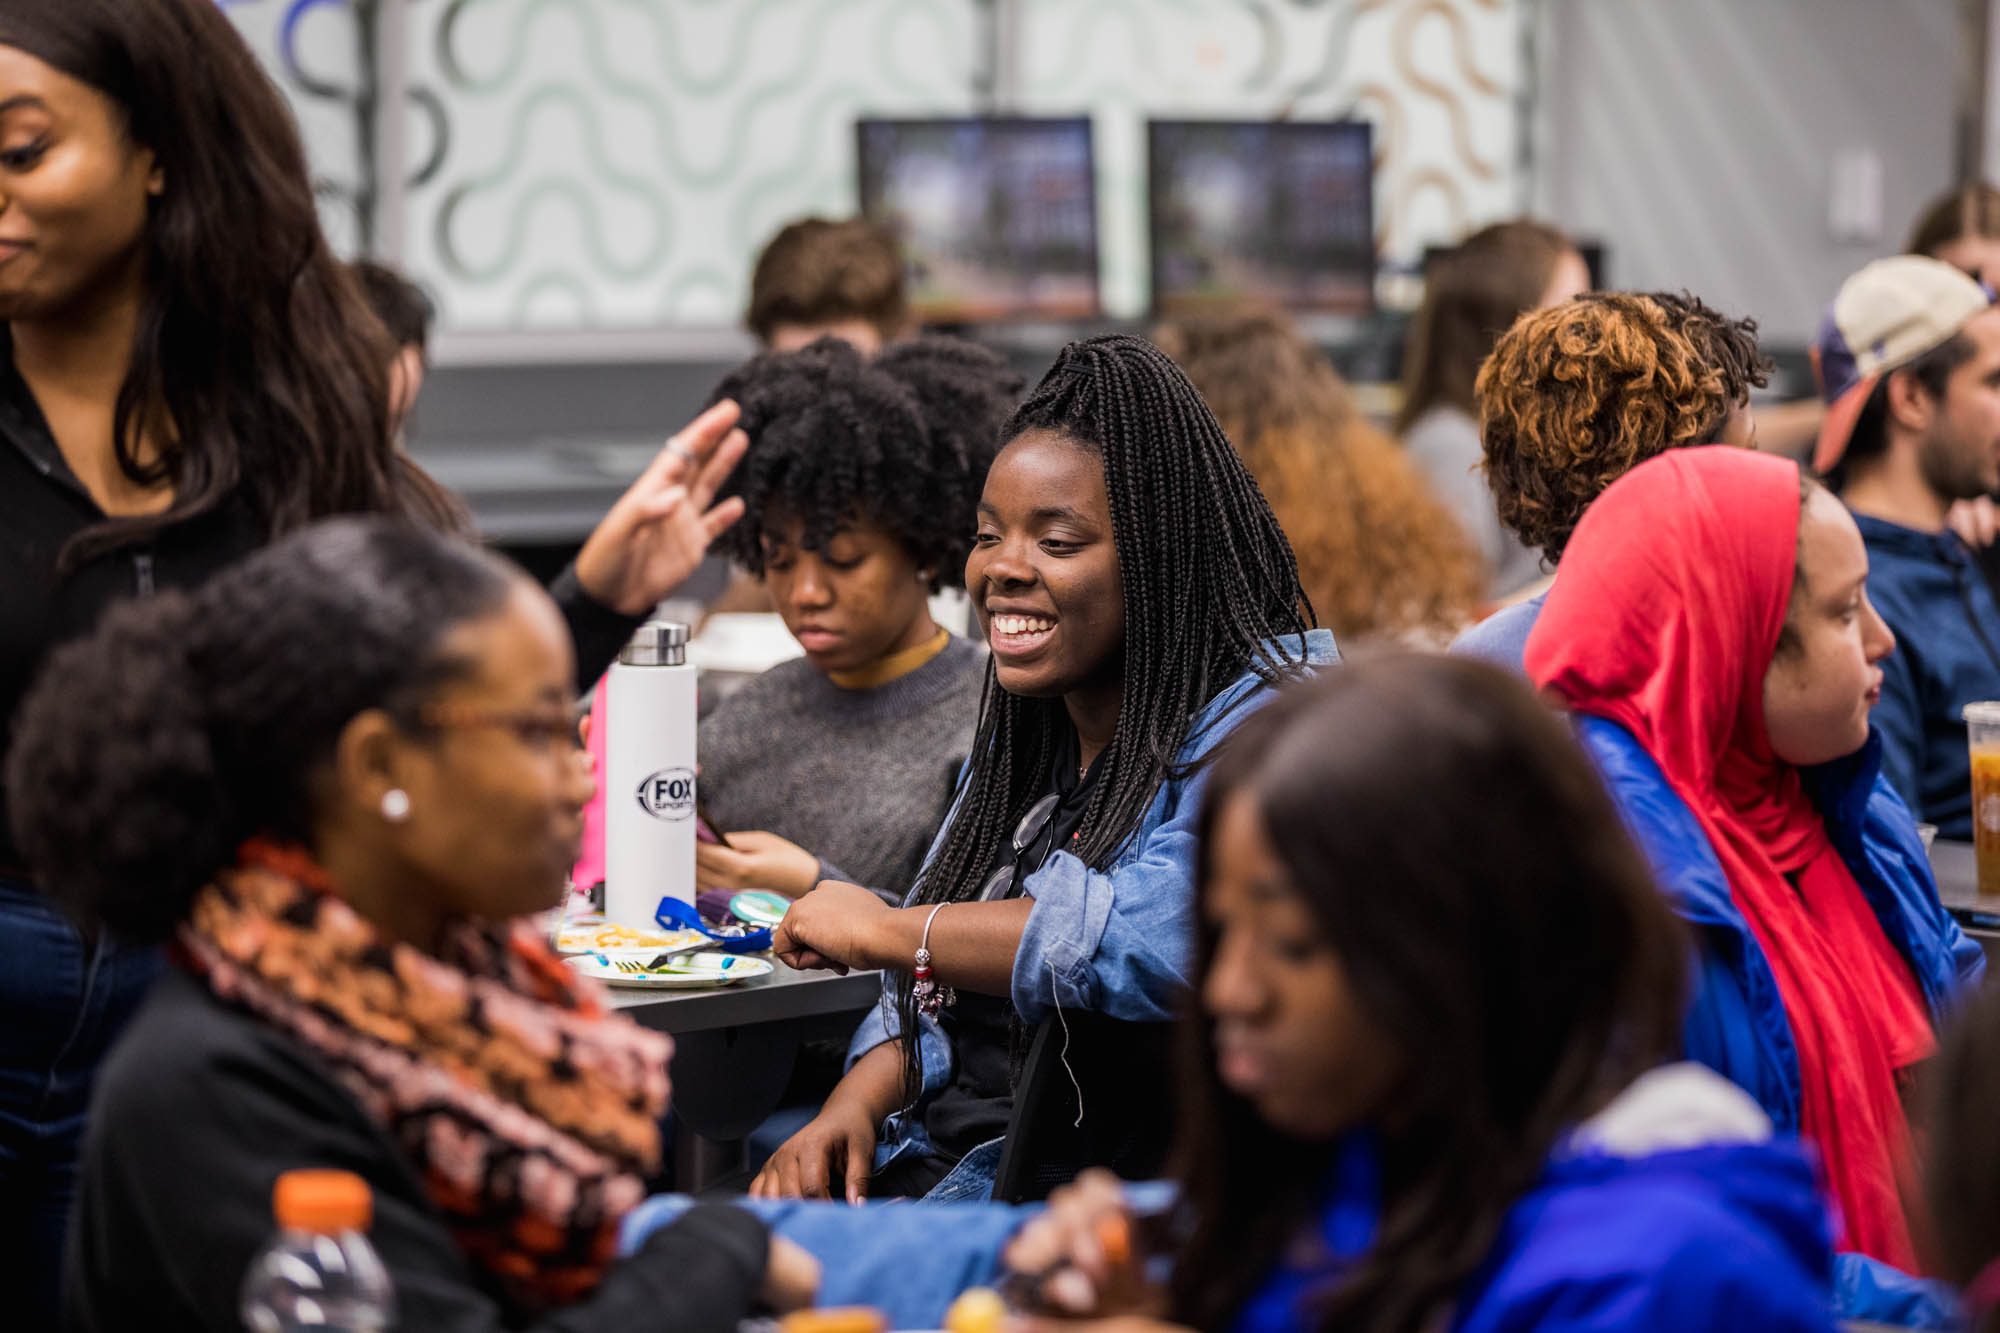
{"left": 1020, "top": 0, "right": 1528, "bottom": 314}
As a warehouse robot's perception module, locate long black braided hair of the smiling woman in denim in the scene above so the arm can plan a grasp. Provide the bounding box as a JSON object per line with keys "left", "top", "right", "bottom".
{"left": 898, "top": 334, "right": 1314, "bottom": 1101}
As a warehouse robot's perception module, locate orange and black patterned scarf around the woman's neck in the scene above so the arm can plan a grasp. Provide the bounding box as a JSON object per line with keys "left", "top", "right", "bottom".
{"left": 180, "top": 841, "right": 672, "bottom": 1309}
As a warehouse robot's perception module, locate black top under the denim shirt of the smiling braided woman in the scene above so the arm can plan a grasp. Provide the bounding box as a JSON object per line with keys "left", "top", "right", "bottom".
{"left": 924, "top": 731, "right": 1096, "bottom": 1161}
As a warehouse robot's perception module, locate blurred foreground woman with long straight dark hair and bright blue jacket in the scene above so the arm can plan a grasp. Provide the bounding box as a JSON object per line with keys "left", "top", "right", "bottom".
{"left": 1008, "top": 658, "right": 1828, "bottom": 1333}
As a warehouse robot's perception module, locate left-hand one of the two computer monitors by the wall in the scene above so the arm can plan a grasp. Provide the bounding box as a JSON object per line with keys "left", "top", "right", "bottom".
{"left": 854, "top": 116, "right": 1100, "bottom": 324}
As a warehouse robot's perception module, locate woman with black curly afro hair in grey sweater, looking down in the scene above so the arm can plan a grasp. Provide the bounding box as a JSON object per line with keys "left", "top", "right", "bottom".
{"left": 696, "top": 338, "right": 1022, "bottom": 899}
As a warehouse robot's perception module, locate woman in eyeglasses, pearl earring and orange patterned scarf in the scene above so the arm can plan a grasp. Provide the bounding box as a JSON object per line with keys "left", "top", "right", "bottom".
{"left": 8, "top": 518, "right": 816, "bottom": 1333}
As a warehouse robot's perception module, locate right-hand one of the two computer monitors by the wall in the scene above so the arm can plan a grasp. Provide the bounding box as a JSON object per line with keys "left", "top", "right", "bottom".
{"left": 1146, "top": 120, "right": 1374, "bottom": 316}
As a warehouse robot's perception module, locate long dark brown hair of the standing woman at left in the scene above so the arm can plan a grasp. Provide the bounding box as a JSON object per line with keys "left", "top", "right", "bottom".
{"left": 0, "top": 0, "right": 464, "bottom": 564}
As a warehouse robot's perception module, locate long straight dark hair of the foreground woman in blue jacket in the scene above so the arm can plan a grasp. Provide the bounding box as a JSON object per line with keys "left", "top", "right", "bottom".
{"left": 1172, "top": 656, "right": 1688, "bottom": 1333}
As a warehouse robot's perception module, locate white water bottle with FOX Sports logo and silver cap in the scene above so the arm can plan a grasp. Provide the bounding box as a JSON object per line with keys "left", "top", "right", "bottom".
{"left": 604, "top": 620, "right": 696, "bottom": 929}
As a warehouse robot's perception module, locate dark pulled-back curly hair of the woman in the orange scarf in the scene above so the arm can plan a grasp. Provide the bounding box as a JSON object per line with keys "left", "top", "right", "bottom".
{"left": 6, "top": 516, "right": 524, "bottom": 943}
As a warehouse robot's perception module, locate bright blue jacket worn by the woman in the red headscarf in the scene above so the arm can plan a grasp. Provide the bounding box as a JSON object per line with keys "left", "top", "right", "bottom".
{"left": 1576, "top": 717, "right": 1986, "bottom": 1323}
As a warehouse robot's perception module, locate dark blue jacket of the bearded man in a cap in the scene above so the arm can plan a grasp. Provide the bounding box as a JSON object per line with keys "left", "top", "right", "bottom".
{"left": 1854, "top": 514, "right": 2000, "bottom": 841}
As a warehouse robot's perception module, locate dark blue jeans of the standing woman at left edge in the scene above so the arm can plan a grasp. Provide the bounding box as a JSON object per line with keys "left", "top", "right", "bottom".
{"left": 0, "top": 873, "right": 160, "bottom": 1329}
